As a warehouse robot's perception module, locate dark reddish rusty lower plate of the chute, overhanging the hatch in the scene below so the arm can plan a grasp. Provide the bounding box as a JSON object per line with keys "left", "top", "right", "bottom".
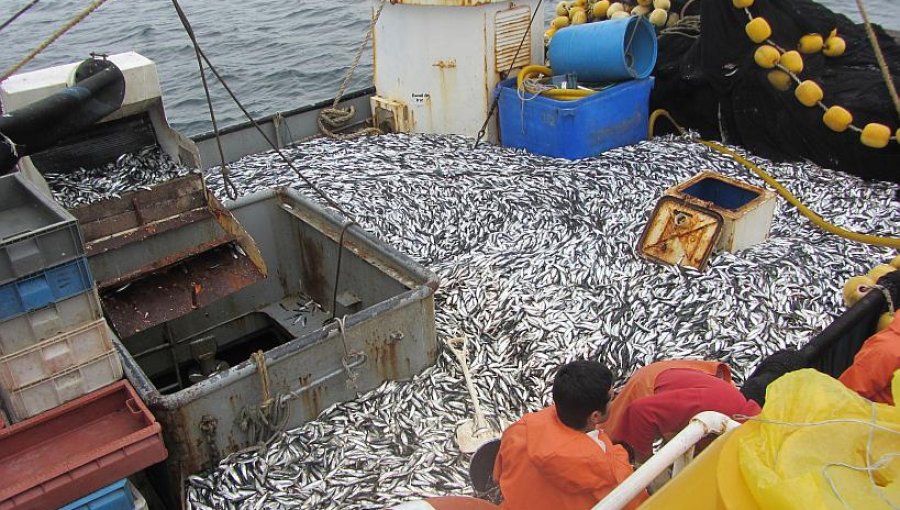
{"left": 102, "top": 245, "right": 263, "bottom": 336}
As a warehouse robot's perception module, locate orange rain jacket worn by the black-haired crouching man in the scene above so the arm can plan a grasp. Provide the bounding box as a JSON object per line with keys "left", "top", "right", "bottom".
{"left": 494, "top": 406, "right": 647, "bottom": 510}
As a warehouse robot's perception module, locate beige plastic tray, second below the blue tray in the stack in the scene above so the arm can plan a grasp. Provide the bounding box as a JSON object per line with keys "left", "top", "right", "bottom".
{"left": 0, "top": 319, "right": 113, "bottom": 391}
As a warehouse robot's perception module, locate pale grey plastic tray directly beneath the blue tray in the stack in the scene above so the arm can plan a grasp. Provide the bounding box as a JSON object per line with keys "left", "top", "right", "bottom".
{"left": 0, "top": 289, "right": 103, "bottom": 356}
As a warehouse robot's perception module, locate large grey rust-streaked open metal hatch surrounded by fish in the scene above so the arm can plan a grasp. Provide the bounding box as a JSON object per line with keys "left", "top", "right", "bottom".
{"left": 118, "top": 189, "right": 438, "bottom": 502}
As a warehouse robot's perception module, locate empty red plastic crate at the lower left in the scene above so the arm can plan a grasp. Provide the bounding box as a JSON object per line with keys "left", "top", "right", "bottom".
{"left": 0, "top": 380, "right": 168, "bottom": 510}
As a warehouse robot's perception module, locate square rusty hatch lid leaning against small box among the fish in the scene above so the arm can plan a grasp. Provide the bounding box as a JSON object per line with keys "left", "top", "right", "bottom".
{"left": 638, "top": 196, "right": 723, "bottom": 269}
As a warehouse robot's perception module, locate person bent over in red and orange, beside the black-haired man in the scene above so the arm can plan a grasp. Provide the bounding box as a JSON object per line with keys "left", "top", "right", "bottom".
{"left": 609, "top": 364, "right": 760, "bottom": 463}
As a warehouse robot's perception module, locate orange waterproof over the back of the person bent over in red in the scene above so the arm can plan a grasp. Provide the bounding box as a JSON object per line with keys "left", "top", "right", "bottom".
{"left": 600, "top": 359, "right": 731, "bottom": 436}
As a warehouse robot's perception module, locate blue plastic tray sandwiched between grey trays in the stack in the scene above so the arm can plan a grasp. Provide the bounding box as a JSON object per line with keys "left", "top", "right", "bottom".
{"left": 0, "top": 257, "right": 94, "bottom": 321}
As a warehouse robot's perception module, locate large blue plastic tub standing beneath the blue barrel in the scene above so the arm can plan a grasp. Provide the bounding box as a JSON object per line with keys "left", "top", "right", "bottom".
{"left": 497, "top": 76, "right": 653, "bottom": 159}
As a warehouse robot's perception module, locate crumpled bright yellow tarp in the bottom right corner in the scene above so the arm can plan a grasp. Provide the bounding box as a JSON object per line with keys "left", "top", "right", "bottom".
{"left": 740, "top": 369, "right": 900, "bottom": 510}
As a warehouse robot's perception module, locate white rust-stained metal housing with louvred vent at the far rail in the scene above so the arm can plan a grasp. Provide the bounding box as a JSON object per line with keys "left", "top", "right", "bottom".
{"left": 373, "top": 0, "right": 544, "bottom": 141}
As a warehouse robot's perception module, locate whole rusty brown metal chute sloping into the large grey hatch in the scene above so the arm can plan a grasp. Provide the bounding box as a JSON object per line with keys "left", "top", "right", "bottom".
{"left": 72, "top": 174, "right": 267, "bottom": 336}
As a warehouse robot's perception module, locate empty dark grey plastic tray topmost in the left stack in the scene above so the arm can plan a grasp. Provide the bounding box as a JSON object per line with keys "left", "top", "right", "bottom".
{"left": 0, "top": 174, "right": 84, "bottom": 285}
